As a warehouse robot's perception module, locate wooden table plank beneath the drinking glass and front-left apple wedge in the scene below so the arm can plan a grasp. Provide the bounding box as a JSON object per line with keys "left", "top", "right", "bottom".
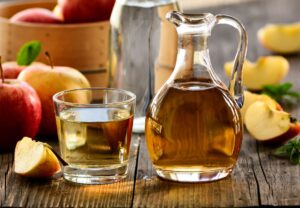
{"left": 0, "top": 136, "right": 139, "bottom": 207}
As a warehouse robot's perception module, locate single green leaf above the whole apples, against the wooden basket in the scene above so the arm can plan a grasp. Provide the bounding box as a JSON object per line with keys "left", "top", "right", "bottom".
{"left": 17, "top": 41, "right": 42, "bottom": 66}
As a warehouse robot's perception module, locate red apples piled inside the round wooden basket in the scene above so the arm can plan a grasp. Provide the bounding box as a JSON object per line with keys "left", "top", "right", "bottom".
{"left": 10, "top": 0, "right": 115, "bottom": 24}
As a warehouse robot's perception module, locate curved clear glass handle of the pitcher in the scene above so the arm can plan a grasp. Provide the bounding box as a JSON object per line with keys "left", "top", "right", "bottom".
{"left": 215, "top": 14, "right": 248, "bottom": 108}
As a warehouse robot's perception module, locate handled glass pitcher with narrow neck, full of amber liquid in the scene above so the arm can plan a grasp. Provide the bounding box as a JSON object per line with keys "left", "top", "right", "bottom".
{"left": 146, "top": 12, "right": 247, "bottom": 182}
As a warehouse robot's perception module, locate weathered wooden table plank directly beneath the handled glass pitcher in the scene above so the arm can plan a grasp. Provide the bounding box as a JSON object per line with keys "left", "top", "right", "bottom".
{"left": 133, "top": 136, "right": 259, "bottom": 207}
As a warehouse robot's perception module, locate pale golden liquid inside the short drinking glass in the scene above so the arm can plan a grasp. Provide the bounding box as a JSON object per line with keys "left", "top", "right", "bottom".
{"left": 56, "top": 108, "right": 133, "bottom": 168}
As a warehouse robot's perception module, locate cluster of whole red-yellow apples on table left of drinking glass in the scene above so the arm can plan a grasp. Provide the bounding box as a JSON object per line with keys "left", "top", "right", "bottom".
{"left": 0, "top": 42, "right": 90, "bottom": 151}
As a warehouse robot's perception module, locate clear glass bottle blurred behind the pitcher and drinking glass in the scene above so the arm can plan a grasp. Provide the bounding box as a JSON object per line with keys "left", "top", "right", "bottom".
{"left": 109, "top": 0, "right": 179, "bottom": 118}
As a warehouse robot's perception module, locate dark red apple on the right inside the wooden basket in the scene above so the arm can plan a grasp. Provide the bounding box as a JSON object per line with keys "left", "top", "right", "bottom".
{"left": 55, "top": 0, "right": 115, "bottom": 23}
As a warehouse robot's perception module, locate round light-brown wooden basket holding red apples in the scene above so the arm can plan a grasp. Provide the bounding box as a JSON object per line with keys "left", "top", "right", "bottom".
{"left": 0, "top": 0, "right": 109, "bottom": 87}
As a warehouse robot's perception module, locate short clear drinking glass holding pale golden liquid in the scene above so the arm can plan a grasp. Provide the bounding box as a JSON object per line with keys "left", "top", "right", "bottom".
{"left": 53, "top": 88, "right": 136, "bottom": 184}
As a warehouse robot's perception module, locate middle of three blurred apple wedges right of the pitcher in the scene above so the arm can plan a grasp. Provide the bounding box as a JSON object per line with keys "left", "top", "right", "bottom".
{"left": 224, "top": 56, "right": 289, "bottom": 90}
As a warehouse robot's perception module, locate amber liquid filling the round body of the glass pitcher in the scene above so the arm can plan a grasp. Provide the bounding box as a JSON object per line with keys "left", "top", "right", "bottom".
{"left": 146, "top": 82, "right": 243, "bottom": 174}
